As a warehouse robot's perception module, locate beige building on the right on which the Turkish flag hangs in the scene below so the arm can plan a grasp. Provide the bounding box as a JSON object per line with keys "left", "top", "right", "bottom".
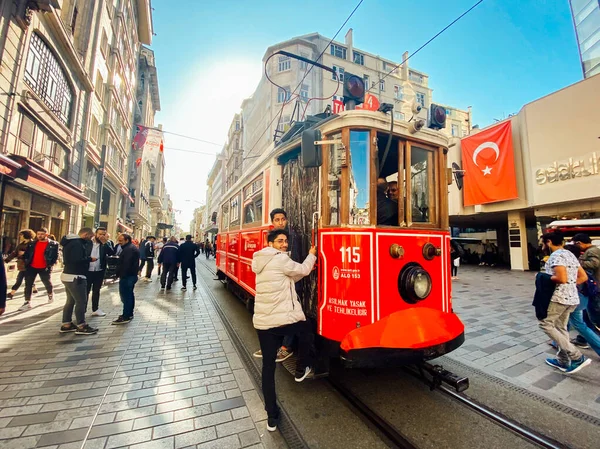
{"left": 448, "top": 76, "right": 600, "bottom": 270}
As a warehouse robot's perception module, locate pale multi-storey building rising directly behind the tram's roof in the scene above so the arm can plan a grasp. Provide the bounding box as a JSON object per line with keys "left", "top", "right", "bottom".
{"left": 241, "top": 29, "right": 471, "bottom": 164}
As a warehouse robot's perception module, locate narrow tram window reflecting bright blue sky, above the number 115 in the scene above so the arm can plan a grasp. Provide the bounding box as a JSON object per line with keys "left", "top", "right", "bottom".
{"left": 348, "top": 131, "right": 370, "bottom": 225}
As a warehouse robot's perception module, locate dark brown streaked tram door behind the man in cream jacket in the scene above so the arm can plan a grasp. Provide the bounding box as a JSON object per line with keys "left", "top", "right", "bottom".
{"left": 282, "top": 157, "right": 319, "bottom": 318}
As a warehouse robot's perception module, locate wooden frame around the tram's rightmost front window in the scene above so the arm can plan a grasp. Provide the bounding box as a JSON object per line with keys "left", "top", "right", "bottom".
{"left": 404, "top": 140, "right": 442, "bottom": 228}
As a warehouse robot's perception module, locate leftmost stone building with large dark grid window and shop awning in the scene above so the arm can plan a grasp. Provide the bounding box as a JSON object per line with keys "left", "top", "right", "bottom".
{"left": 0, "top": 0, "right": 91, "bottom": 271}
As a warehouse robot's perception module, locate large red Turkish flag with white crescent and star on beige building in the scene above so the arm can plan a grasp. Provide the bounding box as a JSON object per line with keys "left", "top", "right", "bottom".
{"left": 461, "top": 120, "right": 518, "bottom": 206}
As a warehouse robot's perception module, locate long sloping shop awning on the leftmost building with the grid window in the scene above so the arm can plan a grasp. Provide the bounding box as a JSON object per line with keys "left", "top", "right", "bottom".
{"left": 9, "top": 154, "right": 88, "bottom": 206}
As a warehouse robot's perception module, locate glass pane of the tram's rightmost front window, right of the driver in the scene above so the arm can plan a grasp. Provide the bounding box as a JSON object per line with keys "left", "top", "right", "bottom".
{"left": 410, "top": 146, "right": 435, "bottom": 223}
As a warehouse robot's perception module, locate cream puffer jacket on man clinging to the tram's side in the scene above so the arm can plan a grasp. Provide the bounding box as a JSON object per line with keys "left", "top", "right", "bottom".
{"left": 252, "top": 246, "right": 317, "bottom": 329}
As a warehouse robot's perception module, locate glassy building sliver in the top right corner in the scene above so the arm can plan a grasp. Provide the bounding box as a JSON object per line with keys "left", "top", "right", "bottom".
{"left": 569, "top": 0, "right": 600, "bottom": 78}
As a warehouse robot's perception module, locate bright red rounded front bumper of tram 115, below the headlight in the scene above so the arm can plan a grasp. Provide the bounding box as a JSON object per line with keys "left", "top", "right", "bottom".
{"left": 340, "top": 307, "right": 465, "bottom": 366}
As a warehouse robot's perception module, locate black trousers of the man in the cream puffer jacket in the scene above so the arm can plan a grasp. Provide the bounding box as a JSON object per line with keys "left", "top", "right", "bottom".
{"left": 256, "top": 321, "right": 313, "bottom": 418}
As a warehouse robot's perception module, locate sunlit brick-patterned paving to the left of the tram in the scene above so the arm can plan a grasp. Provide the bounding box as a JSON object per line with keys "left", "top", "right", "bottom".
{"left": 0, "top": 270, "right": 279, "bottom": 449}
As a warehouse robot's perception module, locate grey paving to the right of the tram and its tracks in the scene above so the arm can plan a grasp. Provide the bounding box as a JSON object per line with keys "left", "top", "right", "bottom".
{"left": 448, "top": 266, "right": 600, "bottom": 417}
